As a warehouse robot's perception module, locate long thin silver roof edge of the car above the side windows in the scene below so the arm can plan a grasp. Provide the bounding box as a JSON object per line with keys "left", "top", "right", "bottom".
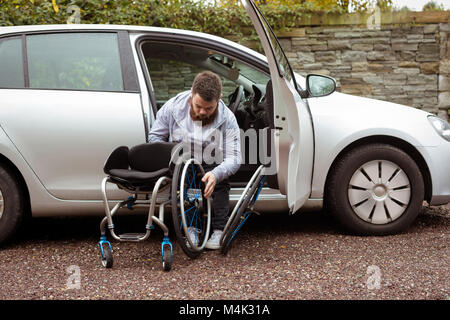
{"left": 0, "top": 24, "right": 267, "bottom": 62}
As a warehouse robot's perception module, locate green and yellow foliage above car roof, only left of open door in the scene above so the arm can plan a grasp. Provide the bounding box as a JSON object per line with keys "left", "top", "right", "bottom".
{"left": 0, "top": 0, "right": 245, "bottom": 33}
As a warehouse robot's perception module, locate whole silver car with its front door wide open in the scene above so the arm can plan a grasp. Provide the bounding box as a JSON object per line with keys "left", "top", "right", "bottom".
{"left": 0, "top": 0, "right": 450, "bottom": 242}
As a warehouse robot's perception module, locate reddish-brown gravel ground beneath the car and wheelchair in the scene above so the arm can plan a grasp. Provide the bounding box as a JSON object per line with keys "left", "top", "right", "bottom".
{"left": 0, "top": 206, "right": 450, "bottom": 300}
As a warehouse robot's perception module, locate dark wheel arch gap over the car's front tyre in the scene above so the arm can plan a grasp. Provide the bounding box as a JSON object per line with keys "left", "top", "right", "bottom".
{"left": 324, "top": 135, "right": 433, "bottom": 203}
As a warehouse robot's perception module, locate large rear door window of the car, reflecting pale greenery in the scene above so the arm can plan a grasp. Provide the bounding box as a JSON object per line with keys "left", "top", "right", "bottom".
{"left": 26, "top": 33, "right": 124, "bottom": 91}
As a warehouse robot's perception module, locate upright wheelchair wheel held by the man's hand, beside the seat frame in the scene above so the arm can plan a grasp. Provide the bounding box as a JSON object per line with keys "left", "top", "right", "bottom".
{"left": 171, "top": 159, "right": 211, "bottom": 259}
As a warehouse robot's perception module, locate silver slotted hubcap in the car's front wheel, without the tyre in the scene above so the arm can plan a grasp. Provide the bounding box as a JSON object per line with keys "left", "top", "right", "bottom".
{"left": 348, "top": 160, "right": 411, "bottom": 224}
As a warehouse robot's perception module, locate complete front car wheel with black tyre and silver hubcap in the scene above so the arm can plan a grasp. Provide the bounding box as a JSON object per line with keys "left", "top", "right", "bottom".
{"left": 326, "top": 144, "right": 424, "bottom": 235}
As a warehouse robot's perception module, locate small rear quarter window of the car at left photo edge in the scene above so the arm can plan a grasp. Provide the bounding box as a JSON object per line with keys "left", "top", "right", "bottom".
{"left": 0, "top": 38, "right": 25, "bottom": 88}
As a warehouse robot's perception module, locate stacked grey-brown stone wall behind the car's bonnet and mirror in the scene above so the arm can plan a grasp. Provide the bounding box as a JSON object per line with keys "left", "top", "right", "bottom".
{"left": 278, "top": 11, "right": 450, "bottom": 121}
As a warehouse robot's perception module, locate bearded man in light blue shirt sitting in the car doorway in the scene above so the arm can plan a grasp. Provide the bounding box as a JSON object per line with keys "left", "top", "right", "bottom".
{"left": 148, "top": 71, "right": 242, "bottom": 249}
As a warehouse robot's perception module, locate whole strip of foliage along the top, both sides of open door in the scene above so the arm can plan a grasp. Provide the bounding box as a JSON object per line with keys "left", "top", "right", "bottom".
{"left": 0, "top": 0, "right": 392, "bottom": 39}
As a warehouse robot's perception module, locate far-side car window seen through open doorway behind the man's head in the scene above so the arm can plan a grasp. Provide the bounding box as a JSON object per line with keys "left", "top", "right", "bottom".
{"left": 142, "top": 41, "right": 269, "bottom": 109}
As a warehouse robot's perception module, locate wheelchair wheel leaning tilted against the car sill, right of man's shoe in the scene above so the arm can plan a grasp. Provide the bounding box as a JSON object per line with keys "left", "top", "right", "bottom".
{"left": 220, "top": 167, "right": 265, "bottom": 255}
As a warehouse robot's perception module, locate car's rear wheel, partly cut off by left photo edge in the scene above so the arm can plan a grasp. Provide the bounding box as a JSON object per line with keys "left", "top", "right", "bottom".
{"left": 0, "top": 165, "right": 25, "bottom": 244}
